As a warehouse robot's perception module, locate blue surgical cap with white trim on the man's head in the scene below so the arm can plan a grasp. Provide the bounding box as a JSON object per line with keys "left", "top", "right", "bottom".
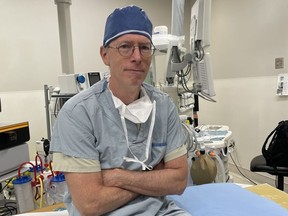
{"left": 103, "top": 6, "right": 153, "bottom": 47}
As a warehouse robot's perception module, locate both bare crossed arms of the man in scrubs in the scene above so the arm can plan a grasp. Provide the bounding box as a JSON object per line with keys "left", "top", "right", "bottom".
{"left": 65, "top": 155, "right": 188, "bottom": 216}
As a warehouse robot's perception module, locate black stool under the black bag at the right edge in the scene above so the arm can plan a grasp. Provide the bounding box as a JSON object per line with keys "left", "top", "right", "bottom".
{"left": 250, "top": 155, "right": 288, "bottom": 190}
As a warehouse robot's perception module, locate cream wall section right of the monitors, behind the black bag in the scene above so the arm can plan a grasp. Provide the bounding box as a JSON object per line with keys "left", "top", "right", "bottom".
{"left": 199, "top": 0, "right": 288, "bottom": 186}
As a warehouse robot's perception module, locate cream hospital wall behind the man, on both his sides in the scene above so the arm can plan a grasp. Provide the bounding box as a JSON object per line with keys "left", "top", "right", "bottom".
{"left": 0, "top": 0, "right": 288, "bottom": 186}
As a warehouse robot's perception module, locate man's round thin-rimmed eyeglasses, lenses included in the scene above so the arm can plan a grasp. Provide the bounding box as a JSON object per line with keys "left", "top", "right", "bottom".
{"left": 107, "top": 42, "right": 155, "bottom": 57}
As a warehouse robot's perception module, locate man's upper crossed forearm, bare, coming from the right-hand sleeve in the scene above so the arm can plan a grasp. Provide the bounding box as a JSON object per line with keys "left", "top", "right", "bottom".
{"left": 102, "top": 155, "right": 188, "bottom": 196}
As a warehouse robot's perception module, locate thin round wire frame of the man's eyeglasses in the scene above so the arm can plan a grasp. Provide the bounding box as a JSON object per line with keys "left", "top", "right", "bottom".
{"left": 106, "top": 42, "right": 156, "bottom": 58}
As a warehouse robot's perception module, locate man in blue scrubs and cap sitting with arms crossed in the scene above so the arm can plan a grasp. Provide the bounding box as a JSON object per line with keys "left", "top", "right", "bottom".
{"left": 51, "top": 6, "right": 190, "bottom": 216}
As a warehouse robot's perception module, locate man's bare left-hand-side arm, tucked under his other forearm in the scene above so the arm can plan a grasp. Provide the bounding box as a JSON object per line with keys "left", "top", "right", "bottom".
{"left": 65, "top": 170, "right": 138, "bottom": 216}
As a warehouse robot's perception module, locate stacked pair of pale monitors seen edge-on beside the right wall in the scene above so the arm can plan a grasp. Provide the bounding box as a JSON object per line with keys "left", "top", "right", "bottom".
{"left": 190, "top": 0, "right": 215, "bottom": 101}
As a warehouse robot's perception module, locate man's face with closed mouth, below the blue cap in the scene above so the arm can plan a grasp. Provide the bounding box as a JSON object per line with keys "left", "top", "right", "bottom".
{"left": 101, "top": 34, "right": 152, "bottom": 87}
